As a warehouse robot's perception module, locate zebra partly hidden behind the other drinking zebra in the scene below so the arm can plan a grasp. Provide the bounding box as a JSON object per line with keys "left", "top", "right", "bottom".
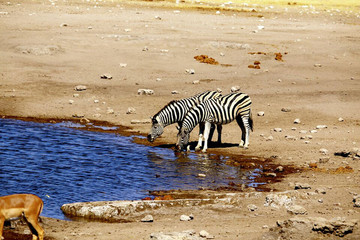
{"left": 147, "top": 91, "right": 221, "bottom": 143}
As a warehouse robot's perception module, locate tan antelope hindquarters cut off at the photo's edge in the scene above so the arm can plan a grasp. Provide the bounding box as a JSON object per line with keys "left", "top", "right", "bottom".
{"left": 0, "top": 194, "right": 44, "bottom": 240}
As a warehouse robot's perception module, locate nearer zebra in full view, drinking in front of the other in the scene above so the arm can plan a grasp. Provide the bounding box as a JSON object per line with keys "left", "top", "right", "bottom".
{"left": 176, "top": 93, "right": 253, "bottom": 152}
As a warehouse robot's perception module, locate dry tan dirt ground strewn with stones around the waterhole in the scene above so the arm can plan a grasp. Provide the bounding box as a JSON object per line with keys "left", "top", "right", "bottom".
{"left": 0, "top": 0, "right": 360, "bottom": 240}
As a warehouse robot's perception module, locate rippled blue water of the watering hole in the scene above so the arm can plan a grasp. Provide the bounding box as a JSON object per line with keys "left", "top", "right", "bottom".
{"left": 0, "top": 119, "right": 262, "bottom": 219}
